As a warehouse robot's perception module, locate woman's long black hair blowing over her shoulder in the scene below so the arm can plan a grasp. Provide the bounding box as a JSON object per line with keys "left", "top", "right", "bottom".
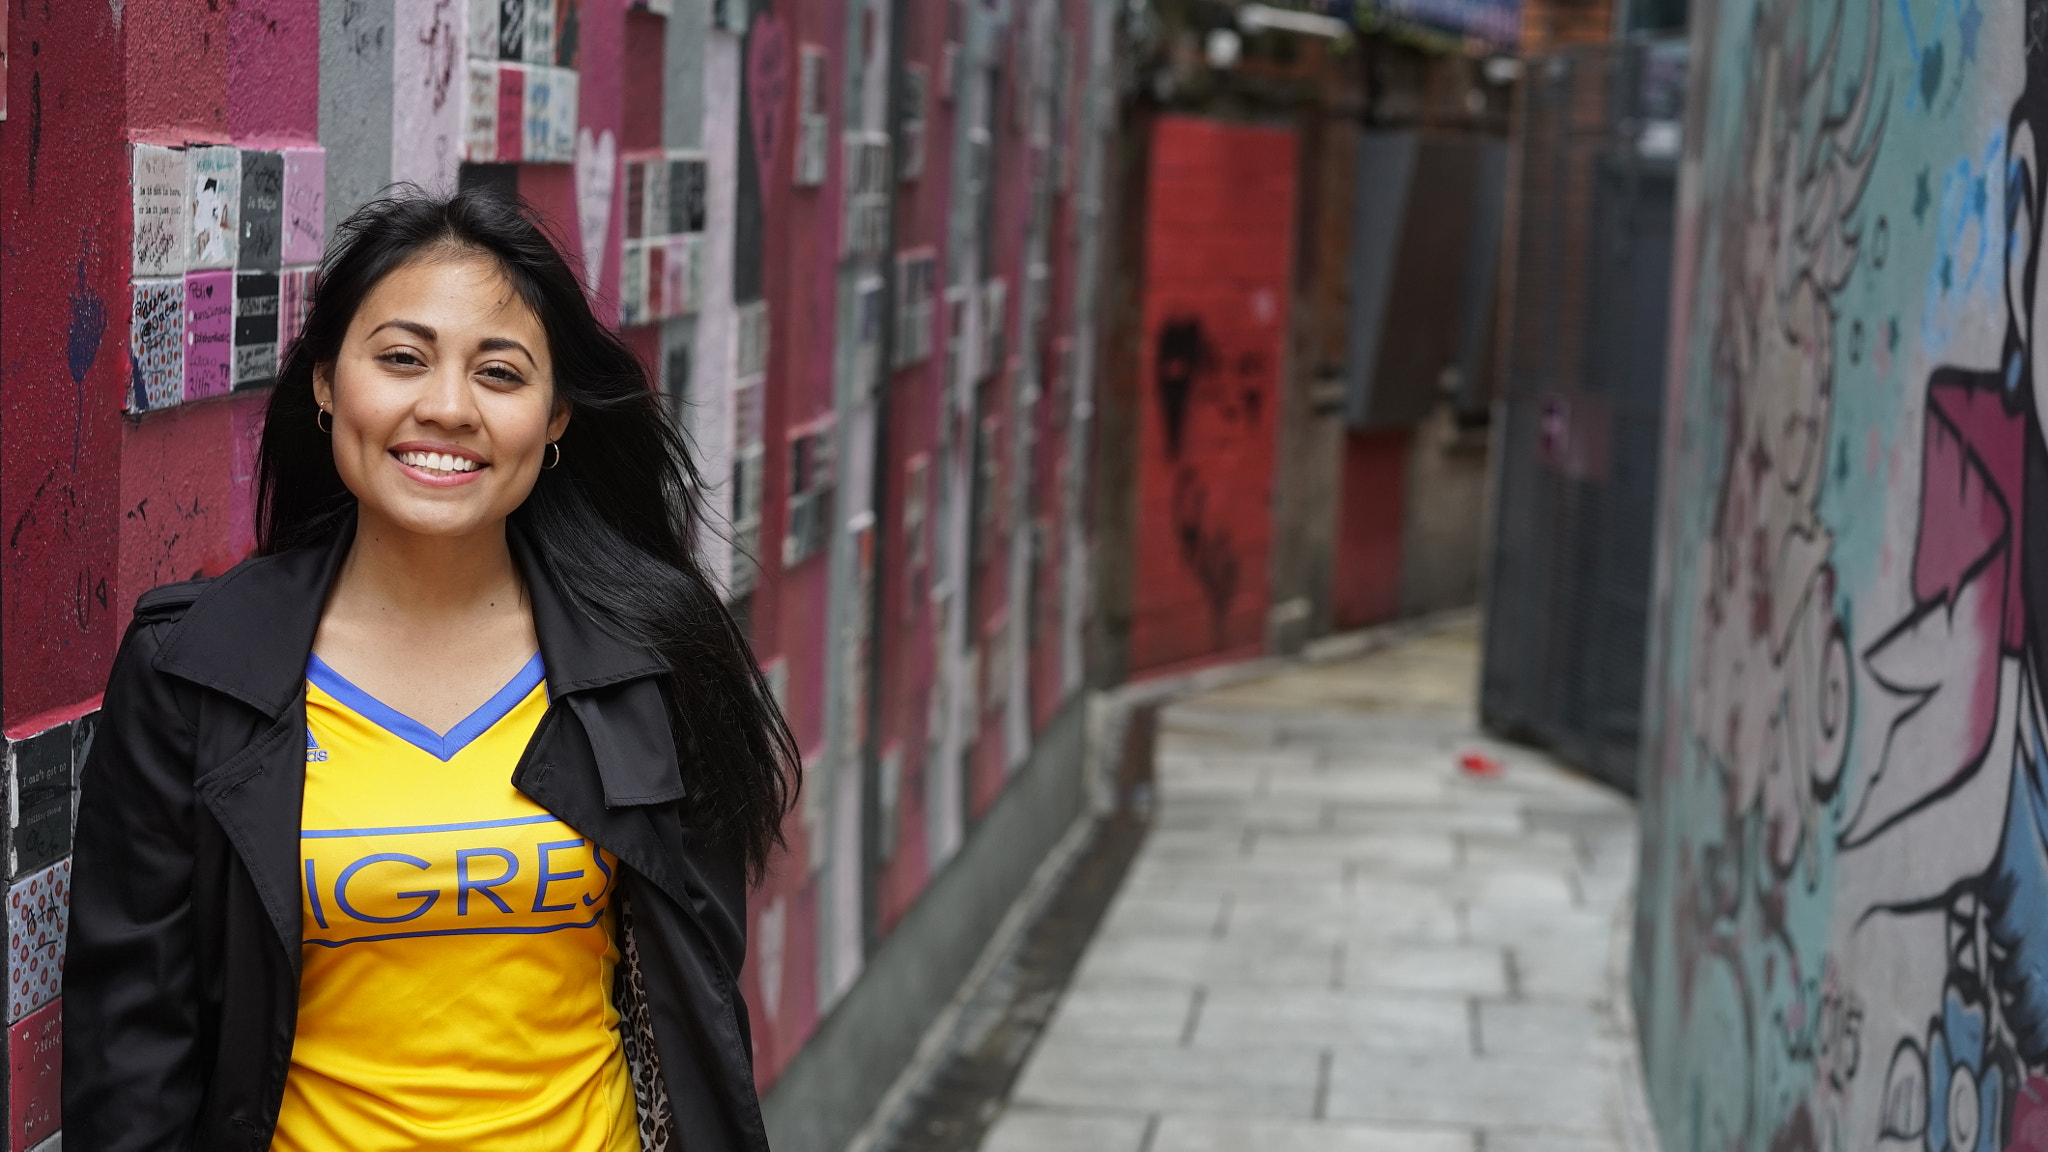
{"left": 256, "top": 189, "right": 803, "bottom": 877}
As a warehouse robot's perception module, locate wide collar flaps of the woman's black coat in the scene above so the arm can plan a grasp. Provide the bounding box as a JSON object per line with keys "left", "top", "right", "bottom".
{"left": 156, "top": 506, "right": 666, "bottom": 719}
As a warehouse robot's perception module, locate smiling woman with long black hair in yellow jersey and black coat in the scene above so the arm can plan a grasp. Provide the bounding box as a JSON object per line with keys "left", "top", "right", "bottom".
{"left": 63, "top": 191, "right": 799, "bottom": 1152}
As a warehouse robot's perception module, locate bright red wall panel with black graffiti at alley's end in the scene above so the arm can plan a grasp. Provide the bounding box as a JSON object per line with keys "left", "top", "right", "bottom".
{"left": 1130, "top": 117, "right": 1294, "bottom": 672}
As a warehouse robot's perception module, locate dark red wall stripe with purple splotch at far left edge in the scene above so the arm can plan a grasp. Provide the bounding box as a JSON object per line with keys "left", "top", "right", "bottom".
{"left": 0, "top": 4, "right": 129, "bottom": 730}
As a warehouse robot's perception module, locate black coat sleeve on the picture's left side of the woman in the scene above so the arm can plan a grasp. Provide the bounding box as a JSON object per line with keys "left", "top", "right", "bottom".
{"left": 63, "top": 619, "right": 203, "bottom": 1152}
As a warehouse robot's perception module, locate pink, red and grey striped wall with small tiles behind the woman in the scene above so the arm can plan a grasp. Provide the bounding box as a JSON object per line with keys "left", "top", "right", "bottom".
{"left": 0, "top": 0, "right": 1114, "bottom": 1131}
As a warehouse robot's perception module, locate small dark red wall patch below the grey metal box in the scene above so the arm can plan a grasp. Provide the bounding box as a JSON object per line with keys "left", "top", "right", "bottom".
{"left": 1329, "top": 428, "right": 1411, "bottom": 627}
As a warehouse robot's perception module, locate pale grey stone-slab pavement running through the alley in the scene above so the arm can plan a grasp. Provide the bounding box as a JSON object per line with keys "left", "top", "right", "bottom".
{"left": 981, "top": 619, "right": 1649, "bottom": 1152}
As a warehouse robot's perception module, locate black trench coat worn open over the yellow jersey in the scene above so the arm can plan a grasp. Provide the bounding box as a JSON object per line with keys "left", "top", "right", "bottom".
{"left": 63, "top": 529, "right": 768, "bottom": 1152}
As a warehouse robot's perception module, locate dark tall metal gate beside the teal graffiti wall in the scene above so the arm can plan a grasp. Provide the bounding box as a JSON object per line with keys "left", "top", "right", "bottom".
{"left": 1481, "top": 39, "right": 1686, "bottom": 791}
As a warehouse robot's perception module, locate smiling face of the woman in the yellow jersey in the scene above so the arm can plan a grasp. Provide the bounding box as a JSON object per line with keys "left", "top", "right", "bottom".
{"left": 313, "top": 252, "right": 569, "bottom": 537}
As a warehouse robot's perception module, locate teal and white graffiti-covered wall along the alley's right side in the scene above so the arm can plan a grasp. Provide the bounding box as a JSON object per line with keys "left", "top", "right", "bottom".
{"left": 1634, "top": 0, "right": 2048, "bottom": 1152}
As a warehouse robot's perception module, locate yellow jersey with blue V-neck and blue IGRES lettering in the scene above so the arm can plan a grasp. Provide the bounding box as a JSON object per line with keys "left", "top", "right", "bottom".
{"left": 270, "top": 656, "right": 639, "bottom": 1152}
